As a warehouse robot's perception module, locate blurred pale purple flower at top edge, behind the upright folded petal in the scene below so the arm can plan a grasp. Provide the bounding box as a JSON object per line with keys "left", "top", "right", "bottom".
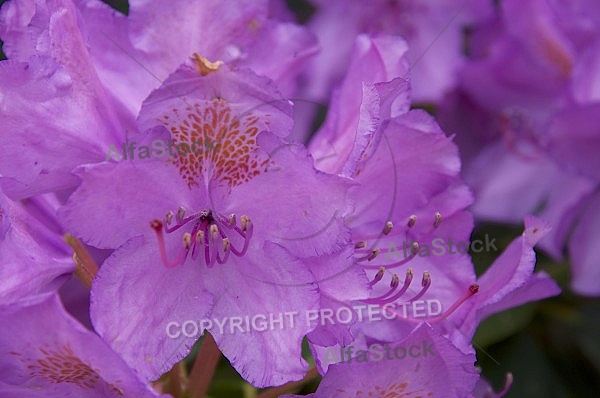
{"left": 300, "top": 0, "right": 491, "bottom": 105}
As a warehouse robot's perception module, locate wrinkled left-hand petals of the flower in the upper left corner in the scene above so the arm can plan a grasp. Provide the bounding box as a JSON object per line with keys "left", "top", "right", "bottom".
{"left": 0, "top": 0, "right": 133, "bottom": 198}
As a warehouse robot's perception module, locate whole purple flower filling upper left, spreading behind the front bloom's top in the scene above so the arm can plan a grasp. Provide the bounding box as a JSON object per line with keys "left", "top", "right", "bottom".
{"left": 0, "top": 0, "right": 316, "bottom": 198}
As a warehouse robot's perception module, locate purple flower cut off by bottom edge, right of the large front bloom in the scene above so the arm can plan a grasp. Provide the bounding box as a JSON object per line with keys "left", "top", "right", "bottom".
{"left": 287, "top": 325, "right": 479, "bottom": 398}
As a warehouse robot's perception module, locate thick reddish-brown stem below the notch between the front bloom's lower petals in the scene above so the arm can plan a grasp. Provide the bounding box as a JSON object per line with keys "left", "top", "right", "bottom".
{"left": 190, "top": 333, "right": 221, "bottom": 398}
